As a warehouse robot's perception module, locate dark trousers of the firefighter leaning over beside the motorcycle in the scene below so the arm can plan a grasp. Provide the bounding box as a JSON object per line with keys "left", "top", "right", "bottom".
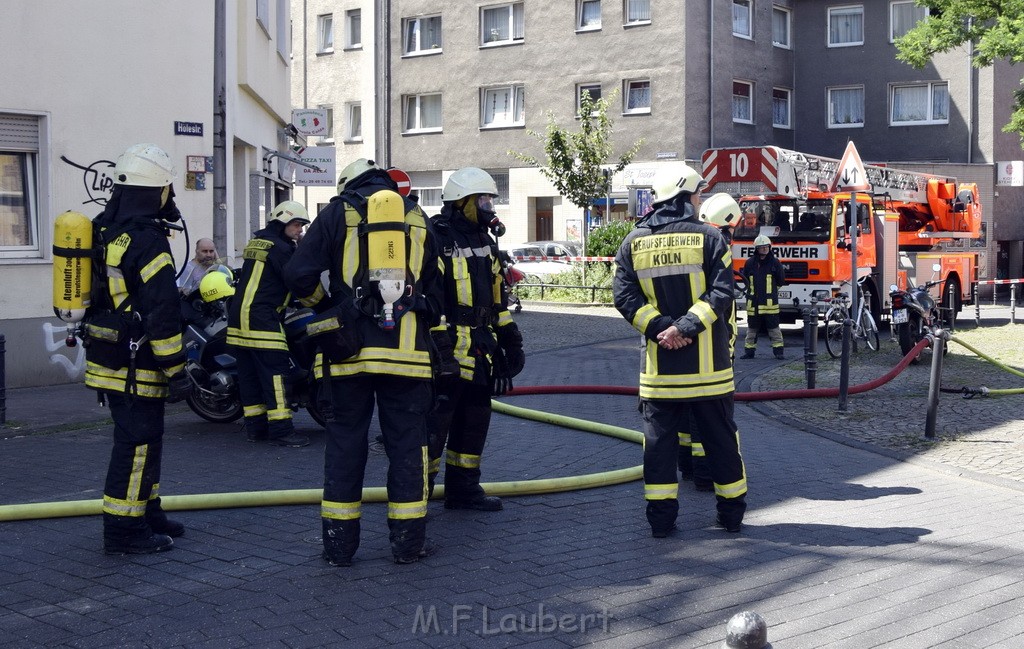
{"left": 231, "top": 346, "right": 295, "bottom": 438}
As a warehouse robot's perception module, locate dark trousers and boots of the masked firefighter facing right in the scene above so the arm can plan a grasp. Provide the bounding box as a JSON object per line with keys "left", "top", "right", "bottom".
{"left": 427, "top": 380, "right": 490, "bottom": 500}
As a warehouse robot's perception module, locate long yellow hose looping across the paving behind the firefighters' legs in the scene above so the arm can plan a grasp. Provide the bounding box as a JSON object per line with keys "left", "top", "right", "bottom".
{"left": 0, "top": 401, "right": 643, "bottom": 521}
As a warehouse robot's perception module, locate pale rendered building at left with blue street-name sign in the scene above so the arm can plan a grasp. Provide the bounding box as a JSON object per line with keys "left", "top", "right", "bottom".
{"left": 0, "top": 0, "right": 291, "bottom": 388}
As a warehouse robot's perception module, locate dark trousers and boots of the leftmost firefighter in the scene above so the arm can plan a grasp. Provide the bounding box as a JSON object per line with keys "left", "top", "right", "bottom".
{"left": 103, "top": 392, "right": 164, "bottom": 540}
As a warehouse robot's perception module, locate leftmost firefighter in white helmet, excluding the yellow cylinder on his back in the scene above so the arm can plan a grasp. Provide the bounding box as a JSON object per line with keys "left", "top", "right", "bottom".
{"left": 85, "top": 144, "right": 191, "bottom": 555}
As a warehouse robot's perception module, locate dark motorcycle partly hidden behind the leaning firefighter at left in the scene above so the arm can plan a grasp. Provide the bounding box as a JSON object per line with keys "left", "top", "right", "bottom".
{"left": 181, "top": 282, "right": 325, "bottom": 426}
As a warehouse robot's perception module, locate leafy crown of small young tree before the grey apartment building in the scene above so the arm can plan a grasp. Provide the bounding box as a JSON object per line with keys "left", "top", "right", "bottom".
{"left": 508, "top": 91, "right": 643, "bottom": 210}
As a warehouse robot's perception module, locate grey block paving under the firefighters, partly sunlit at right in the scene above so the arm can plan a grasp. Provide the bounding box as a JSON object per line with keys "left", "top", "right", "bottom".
{"left": 0, "top": 304, "right": 1024, "bottom": 649}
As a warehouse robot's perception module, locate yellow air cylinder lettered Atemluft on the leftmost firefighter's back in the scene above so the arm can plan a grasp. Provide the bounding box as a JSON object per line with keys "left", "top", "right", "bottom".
{"left": 53, "top": 212, "right": 92, "bottom": 347}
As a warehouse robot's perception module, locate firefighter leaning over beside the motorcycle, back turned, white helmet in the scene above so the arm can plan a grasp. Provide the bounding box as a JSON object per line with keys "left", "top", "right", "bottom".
{"left": 227, "top": 201, "right": 309, "bottom": 448}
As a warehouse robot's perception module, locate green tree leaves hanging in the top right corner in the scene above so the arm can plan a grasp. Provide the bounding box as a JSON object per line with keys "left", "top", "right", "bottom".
{"left": 896, "top": 0, "right": 1024, "bottom": 142}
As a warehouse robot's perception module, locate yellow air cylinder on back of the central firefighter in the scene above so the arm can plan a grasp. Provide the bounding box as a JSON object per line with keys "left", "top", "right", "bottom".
{"left": 367, "top": 189, "right": 406, "bottom": 330}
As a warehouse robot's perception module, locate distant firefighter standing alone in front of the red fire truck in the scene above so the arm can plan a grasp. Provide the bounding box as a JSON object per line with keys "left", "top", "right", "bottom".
{"left": 742, "top": 234, "right": 785, "bottom": 360}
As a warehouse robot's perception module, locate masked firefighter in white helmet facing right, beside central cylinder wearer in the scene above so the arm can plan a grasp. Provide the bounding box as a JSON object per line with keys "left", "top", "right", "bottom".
{"left": 428, "top": 167, "right": 525, "bottom": 512}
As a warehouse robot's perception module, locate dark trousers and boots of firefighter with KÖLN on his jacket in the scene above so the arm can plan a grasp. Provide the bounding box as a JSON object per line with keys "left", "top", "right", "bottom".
{"left": 642, "top": 394, "right": 746, "bottom": 530}
